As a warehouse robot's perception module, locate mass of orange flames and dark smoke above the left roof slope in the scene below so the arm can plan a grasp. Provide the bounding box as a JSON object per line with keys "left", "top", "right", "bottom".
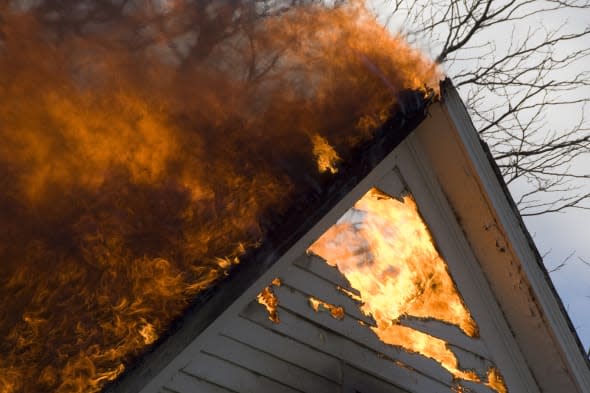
{"left": 0, "top": 0, "right": 439, "bottom": 393}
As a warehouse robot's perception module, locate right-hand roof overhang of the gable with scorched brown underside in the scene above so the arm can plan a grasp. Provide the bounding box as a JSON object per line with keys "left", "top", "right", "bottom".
{"left": 415, "top": 83, "right": 590, "bottom": 392}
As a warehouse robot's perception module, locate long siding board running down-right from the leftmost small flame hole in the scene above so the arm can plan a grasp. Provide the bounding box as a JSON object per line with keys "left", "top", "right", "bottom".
{"left": 266, "top": 287, "right": 452, "bottom": 385}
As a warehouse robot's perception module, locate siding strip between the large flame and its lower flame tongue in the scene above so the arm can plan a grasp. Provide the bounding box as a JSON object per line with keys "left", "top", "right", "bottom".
{"left": 400, "top": 318, "right": 490, "bottom": 359}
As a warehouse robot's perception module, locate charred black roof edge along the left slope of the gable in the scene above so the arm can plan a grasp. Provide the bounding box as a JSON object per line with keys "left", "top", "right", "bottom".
{"left": 102, "top": 90, "right": 434, "bottom": 393}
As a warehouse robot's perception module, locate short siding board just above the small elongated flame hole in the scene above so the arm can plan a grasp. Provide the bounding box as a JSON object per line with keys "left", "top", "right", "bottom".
{"left": 279, "top": 265, "right": 375, "bottom": 326}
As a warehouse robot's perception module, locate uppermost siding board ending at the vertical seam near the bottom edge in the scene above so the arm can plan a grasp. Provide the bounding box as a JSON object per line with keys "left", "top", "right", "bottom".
{"left": 220, "top": 318, "right": 341, "bottom": 383}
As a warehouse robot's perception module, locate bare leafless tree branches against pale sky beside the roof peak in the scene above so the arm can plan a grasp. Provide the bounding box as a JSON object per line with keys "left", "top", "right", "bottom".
{"left": 375, "top": 0, "right": 590, "bottom": 216}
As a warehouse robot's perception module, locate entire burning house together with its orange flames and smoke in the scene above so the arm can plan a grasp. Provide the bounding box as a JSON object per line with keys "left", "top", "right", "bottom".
{"left": 0, "top": 1, "right": 590, "bottom": 393}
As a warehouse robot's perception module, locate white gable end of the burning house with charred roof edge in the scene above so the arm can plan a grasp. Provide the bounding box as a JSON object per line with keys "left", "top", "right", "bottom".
{"left": 100, "top": 82, "right": 590, "bottom": 393}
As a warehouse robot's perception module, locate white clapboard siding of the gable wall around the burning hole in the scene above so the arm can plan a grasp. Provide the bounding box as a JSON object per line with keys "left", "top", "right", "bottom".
{"left": 163, "top": 237, "right": 500, "bottom": 393}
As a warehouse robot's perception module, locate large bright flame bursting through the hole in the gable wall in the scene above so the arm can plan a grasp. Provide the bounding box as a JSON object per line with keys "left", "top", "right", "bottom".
{"left": 308, "top": 188, "right": 508, "bottom": 391}
